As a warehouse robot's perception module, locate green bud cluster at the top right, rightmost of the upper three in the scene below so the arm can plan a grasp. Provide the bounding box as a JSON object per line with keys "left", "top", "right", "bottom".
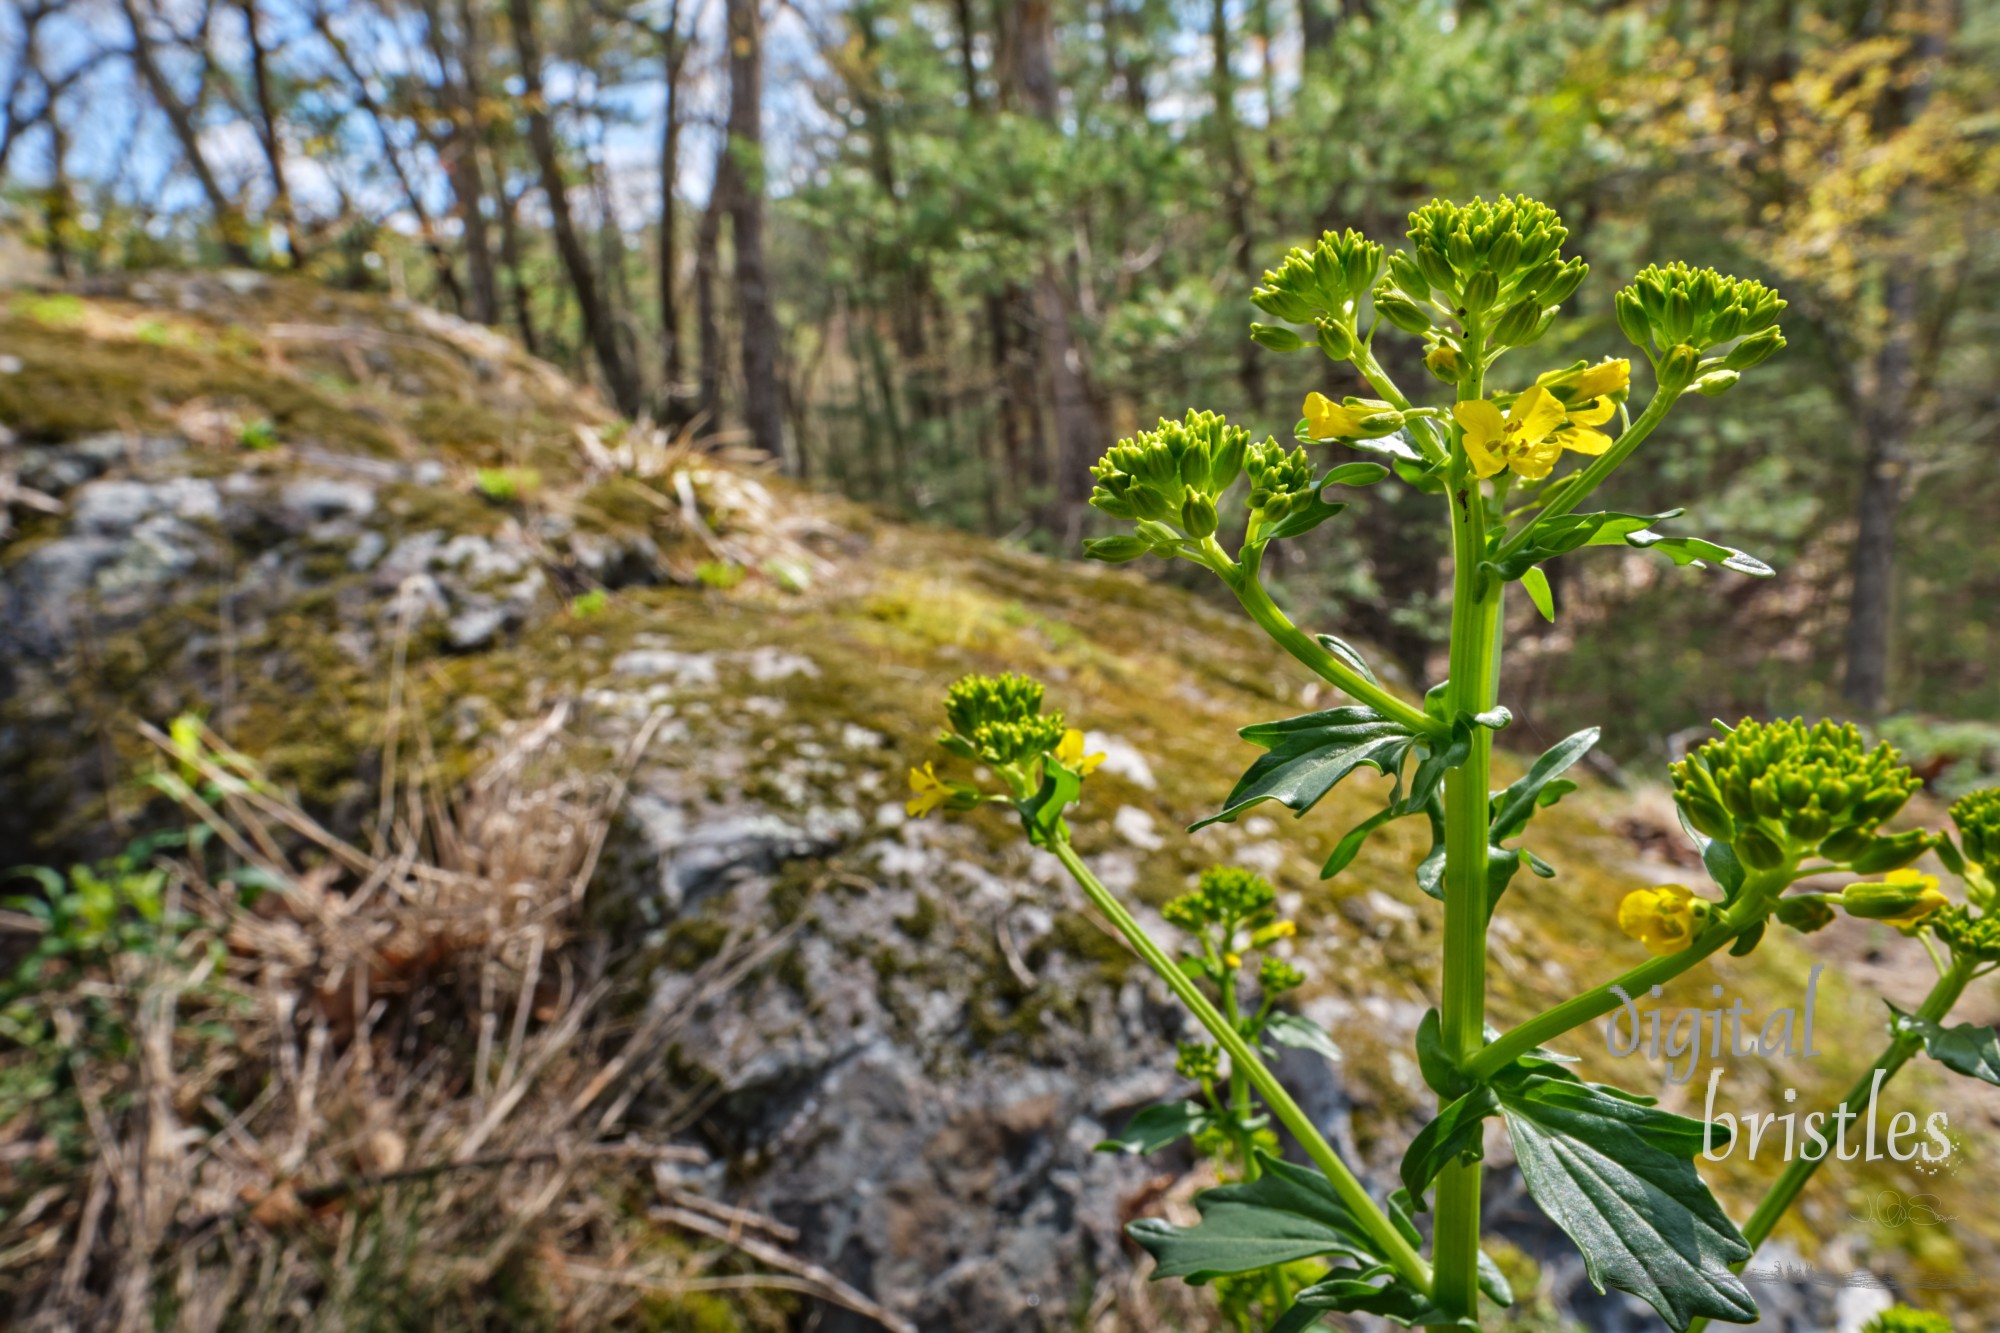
{"left": 1614, "top": 262, "right": 1786, "bottom": 398}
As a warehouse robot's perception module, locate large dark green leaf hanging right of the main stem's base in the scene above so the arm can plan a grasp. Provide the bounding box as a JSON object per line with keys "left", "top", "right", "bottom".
{"left": 1496, "top": 1073, "right": 1758, "bottom": 1329}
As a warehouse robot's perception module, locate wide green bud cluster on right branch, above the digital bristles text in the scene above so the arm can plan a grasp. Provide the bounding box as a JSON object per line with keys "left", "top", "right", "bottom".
{"left": 1672, "top": 719, "right": 1930, "bottom": 875}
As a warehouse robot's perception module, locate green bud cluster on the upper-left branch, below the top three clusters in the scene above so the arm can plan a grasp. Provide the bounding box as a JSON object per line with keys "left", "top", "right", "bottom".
{"left": 1084, "top": 412, "right": 1250, "bottom": 560}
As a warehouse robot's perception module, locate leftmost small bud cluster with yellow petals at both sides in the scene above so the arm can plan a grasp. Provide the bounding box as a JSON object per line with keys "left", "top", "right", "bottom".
{"left": 904, "top": 673, "right": 1104, "bottom": 819}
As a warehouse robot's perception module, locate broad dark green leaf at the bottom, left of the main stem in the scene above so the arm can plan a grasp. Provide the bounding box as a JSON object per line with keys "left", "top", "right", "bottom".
{"left": 1126, "top": 1153, "right": 1378, "bottom": 1283}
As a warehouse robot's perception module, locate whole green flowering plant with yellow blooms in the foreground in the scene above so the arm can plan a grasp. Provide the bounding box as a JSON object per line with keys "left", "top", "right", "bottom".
{"left": 912, "top": 198, "right": 2000, "bottom": 1333}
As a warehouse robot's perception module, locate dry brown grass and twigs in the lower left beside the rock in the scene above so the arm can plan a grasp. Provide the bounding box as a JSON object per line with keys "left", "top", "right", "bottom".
{"left": 0, "top": 689, "right": 908, "bottom": 1331}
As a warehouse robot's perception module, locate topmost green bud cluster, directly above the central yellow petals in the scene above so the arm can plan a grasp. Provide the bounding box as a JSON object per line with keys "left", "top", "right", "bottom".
{"left": 1400, "top": 194, "right": 1590, "bottom": 344}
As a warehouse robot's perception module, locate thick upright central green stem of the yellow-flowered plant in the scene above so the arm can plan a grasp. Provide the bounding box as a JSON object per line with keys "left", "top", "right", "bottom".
{"left": 1432, "top": 322, "right": 1504, "bottom": 1317}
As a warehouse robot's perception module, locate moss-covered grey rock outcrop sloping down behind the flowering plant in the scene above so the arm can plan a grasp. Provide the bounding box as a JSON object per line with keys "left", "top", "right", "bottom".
{"left": 0, "top": 274, "right": 2000, "bottom": 1331}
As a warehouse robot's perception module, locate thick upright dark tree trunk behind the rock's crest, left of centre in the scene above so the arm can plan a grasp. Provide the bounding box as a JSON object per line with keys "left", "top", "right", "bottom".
{"left": 724, "top": 0, "right": 784, "bottom": 458}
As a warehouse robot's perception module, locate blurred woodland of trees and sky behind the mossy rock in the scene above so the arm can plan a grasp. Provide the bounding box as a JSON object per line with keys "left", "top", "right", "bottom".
{"left": 0, "top": 0, "right": 2000, "bottom": 765}
